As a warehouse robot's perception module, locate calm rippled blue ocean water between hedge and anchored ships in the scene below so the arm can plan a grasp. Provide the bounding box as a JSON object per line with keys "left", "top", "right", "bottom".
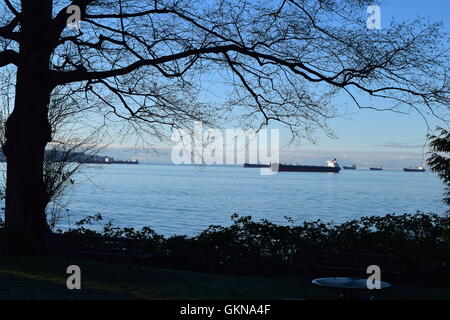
{"left": 47, "top": 164, "right": 447, "bottom": 236}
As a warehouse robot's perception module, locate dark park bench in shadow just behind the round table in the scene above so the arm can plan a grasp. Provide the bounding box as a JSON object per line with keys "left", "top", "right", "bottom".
{"left": 295, "top": 249, "right": 403, "bottom": 279}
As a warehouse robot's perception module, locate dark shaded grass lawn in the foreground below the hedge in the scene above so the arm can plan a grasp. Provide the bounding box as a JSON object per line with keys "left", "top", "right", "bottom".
{"left": 0, "top": 256, "right": 450, "bottom": 300}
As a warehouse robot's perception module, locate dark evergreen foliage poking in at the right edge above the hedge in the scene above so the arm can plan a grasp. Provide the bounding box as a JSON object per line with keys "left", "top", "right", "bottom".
{"left": 427, "top": 128, "right": 450, "bottom": 205}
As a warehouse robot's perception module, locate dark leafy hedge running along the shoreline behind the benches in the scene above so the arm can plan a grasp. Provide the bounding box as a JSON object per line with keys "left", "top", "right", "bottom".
{"left": 58, "top": 212, "right": 450, "bottom": 274}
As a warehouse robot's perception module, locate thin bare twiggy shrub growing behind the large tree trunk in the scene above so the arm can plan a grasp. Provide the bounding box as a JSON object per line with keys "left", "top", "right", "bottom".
{"left": 0, "top": 70, "right": 105, "bottom": 242}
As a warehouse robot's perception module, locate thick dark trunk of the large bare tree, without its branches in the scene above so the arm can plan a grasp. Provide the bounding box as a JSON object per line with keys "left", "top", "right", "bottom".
{"left": 3, "top": 0, "right": 52, "bottom": 250}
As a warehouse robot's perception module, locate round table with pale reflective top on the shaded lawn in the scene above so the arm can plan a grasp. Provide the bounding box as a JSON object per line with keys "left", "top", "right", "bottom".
{"left": 312, "top": 277, "right": 391, "bottom": 300}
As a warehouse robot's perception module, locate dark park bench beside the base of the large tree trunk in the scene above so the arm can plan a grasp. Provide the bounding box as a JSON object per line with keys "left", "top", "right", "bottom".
{"left": 47, "top": 234, "right": 152, "bottom": 273}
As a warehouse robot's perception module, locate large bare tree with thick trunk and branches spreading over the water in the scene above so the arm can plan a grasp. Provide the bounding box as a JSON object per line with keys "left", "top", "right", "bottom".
{"left": 0, "top": 0, "right": 449, "bottom": 248}
